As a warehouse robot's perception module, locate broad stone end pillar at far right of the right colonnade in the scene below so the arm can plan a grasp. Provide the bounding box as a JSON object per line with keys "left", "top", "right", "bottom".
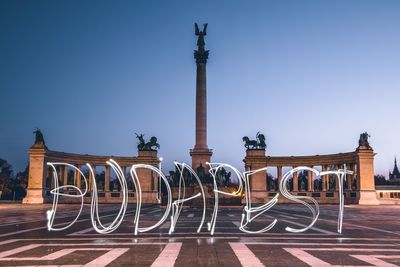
{"left": 356, "top": 146, "right": 379, "bottom": 205}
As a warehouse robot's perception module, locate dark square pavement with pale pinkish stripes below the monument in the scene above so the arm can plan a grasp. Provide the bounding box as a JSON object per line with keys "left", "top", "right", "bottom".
{"left": 0, "top": 204, "right": 400, "bottom": 267}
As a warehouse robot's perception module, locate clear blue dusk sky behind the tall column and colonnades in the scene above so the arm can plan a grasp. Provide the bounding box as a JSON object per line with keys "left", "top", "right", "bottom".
{"left": 0, "top": 0, "right": 400, "bottom": 175}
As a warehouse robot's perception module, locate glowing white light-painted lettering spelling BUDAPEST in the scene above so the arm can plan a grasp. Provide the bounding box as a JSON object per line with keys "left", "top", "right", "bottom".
{"left": 47, "top": 159, "right": 353, "bottom": 235}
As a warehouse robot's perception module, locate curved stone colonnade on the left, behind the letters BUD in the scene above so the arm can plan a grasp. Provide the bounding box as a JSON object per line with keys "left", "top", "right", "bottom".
{"left": 23, "top": 144, "right": 160, "bottom": 204}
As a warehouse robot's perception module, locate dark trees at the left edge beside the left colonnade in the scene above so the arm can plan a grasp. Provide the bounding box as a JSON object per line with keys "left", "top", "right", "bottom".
{"left": 0, "top": 159, "right": 29, "bottom": 200}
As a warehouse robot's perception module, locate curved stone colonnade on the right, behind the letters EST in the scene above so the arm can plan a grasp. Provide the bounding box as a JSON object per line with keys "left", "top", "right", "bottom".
{"left": 244, "top": 146, "right": 379, "bottom": 204}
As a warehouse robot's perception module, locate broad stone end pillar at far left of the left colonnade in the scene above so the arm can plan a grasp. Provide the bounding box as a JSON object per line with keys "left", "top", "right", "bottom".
{"left": 22, "top": 144, "right": 47, "bottom": 204}
